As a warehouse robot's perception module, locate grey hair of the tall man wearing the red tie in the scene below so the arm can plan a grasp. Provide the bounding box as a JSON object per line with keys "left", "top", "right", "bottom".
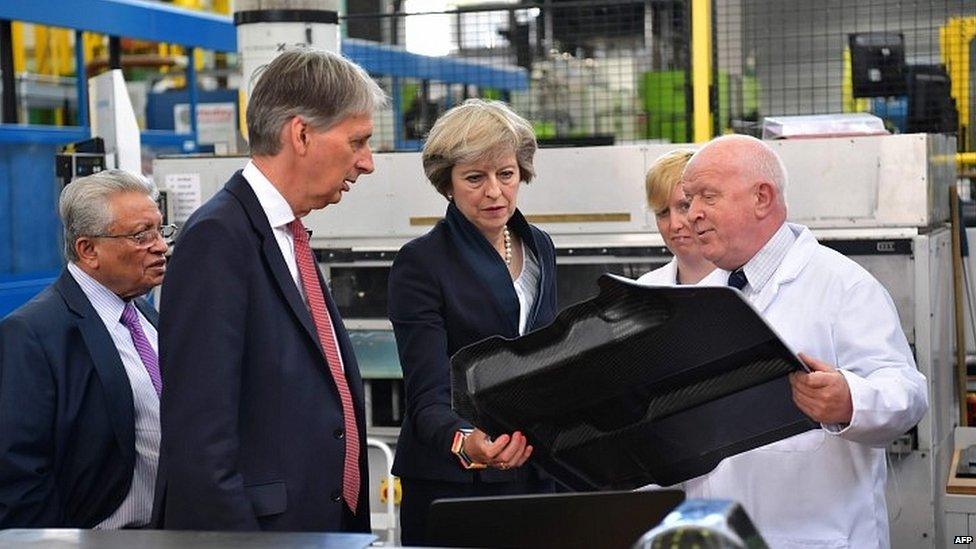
{"left": 247, "top": 47, "right": 386, "bottom": 156}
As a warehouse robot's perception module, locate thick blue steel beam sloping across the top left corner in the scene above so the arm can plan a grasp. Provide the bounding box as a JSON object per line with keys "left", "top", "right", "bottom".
{"left": 0, "top": 0, "right": 237, "bottom": 52}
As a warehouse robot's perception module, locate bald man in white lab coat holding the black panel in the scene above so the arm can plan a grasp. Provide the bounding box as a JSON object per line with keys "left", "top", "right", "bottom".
{"left": 682, "top": 136, "right": 928, "bottom": 549}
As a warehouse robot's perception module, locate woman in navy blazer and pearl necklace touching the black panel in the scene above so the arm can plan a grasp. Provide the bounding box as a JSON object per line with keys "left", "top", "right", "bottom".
{"left": 389, "top": 99, "right": 556, "bottom": 545}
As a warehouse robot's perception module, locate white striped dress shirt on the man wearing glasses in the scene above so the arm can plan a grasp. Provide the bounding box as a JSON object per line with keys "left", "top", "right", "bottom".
{"left": 68, "top": 263, "right": 159, "bottom": 530}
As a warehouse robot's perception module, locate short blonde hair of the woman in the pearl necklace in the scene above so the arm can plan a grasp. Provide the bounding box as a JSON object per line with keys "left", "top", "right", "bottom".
{"left": 422, "top": 99, "right": 538, "bottom": 197}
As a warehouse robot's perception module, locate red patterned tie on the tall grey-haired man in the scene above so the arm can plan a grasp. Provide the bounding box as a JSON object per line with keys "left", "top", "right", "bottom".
{"left": 288, "top": 219, "right": 359, "bottom": 514}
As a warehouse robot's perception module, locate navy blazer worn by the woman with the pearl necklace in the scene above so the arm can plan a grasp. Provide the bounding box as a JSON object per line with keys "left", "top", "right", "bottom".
{"left": 389, "top": 203, "right": 556, "bottom": 482}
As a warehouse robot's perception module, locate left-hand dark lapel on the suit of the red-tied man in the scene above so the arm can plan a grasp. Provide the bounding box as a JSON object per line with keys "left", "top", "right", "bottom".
{"left": 226, "top": 172, "right": 322, "bottom": 358}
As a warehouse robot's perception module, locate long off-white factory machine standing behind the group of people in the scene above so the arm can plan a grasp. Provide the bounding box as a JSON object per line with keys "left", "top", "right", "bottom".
{"left": 154, "top": 134, "right": 956, "bottom": 548}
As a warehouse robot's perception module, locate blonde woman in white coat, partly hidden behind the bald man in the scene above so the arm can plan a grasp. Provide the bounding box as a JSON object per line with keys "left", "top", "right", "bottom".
{"left": 637, "top": 149, "right": 715, "bottom": 286}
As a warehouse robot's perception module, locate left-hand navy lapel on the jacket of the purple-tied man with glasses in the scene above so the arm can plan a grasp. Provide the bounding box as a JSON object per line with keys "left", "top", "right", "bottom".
{"left": 55, "top": 269, "right": 134, "bottom": 459}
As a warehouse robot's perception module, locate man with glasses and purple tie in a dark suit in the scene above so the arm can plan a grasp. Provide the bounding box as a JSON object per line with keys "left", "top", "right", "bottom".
{"left": 0, "top": 170, "right": 172, "bottom": 529}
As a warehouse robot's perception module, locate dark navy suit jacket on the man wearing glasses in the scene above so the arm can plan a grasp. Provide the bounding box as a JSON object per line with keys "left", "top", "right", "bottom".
{"left": 0, "top": 269, "right": 157, "bottom": 528}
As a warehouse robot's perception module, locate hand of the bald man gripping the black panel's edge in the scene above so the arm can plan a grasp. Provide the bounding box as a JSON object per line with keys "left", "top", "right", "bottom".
{"left": 790, "top": 353, "right": 854, "bottom": 423}
